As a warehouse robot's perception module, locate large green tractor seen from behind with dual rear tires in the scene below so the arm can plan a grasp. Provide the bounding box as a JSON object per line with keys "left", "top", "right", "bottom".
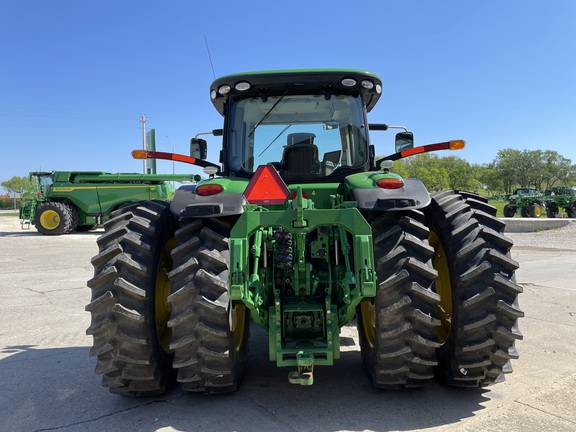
{"left": 86, "top": 69, "right": 523, "bottom": 395}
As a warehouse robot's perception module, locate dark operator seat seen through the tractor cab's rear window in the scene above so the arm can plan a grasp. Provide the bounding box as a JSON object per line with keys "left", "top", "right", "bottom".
{"left": 280, "top": 132, "right": 320, "bottom": 179}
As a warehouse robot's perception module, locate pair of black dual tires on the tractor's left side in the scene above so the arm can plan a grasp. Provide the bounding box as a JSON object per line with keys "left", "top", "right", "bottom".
{"left": 86, "top": 201, "right": 249, "bottom": 396}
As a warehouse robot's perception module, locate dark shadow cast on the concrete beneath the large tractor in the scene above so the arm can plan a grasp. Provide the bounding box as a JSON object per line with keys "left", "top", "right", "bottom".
{"left": 0, "top": 325, "right": 490, "bottom": 432}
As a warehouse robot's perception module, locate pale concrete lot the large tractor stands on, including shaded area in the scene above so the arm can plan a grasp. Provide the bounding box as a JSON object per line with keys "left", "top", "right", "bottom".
{"left": 0, "top": 216, "right": 576, "bottom": 432}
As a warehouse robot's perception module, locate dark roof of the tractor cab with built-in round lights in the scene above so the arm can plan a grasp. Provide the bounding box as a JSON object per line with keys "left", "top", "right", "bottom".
{"left": 210, "top": 69, "right": 382, "bottom": 115}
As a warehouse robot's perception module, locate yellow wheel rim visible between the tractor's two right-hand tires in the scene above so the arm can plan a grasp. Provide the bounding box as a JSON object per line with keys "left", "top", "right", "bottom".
{"left": 428, "top": 232, "right": 452, "bottom": 343}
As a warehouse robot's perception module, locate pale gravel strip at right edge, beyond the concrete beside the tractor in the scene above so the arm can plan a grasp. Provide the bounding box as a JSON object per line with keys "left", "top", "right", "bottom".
{"left": 506, "top": 221, "right": 576, "bottom": 252}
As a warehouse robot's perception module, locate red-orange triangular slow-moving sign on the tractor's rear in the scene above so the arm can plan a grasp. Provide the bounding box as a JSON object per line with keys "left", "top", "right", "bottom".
{"left": 244, "top": 165, "right": 290, "bottom": 205}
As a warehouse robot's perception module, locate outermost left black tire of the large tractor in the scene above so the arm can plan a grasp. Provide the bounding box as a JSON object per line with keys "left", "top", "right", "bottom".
{"left": 86, "top": 201, "right": 175, "bottom": 396}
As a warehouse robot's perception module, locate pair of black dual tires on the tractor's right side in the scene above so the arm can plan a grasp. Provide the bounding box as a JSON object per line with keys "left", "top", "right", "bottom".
{"left": 358, "top": 191, "right": 523, "bottom": 389}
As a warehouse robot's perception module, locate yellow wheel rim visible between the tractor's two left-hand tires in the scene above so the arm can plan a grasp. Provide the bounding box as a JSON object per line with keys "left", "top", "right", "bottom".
{"left": 154, "top": 238, "right": 176, "bottom": 352}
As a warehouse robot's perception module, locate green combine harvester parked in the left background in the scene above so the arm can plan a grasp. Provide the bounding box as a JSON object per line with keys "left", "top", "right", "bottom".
{"left": 20, "top": 171, "right": 199, "bottom": 235}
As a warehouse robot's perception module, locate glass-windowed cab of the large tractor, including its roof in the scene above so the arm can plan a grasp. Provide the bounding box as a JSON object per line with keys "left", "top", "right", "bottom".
{"left": 211, "top": 70, "right": 382, "bottom": 183}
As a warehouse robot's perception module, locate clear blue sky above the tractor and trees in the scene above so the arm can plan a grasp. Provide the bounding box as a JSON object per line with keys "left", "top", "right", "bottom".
{"left": 0, "top": 0, "right": 576, "bottom": 188}
